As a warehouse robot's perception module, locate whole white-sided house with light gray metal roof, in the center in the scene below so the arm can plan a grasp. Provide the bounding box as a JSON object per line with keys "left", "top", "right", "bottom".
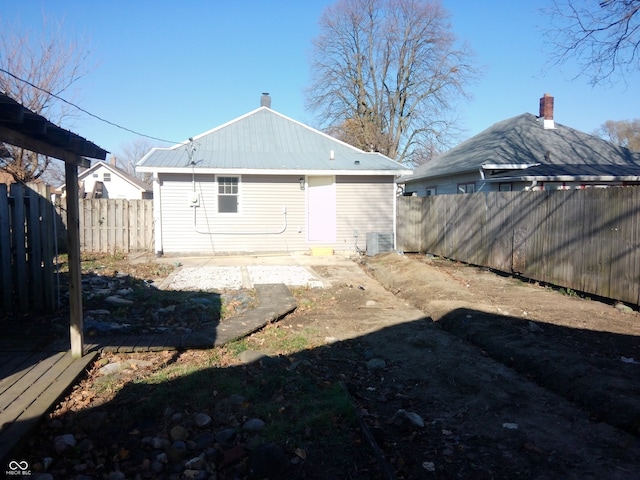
{"left": 136, "top": 95, "right": 411, "bottom": 254}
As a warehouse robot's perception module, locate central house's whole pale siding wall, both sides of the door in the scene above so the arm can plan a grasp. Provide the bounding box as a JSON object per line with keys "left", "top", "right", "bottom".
{"left": 156, "top": 174, "right": 395, "bottom": 254}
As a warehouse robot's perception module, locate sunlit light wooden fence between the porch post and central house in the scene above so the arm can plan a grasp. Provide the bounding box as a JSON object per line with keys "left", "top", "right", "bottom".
{"left": 58, "top": 198, "right": 153, "bottom": 253}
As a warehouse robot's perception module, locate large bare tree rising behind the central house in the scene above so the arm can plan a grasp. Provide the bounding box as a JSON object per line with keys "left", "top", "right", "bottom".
{"left": 306, "top": 0, "right": 476, "bottom": 163}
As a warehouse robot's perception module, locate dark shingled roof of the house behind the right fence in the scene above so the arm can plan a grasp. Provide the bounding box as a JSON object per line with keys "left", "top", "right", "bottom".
{"left": 406, "top": 113, "right": 640, "bottom": 183}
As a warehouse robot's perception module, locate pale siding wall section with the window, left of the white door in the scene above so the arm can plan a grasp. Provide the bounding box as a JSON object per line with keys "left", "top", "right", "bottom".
{"left": 160, "top": 175, "right": 306, "bottom": 254}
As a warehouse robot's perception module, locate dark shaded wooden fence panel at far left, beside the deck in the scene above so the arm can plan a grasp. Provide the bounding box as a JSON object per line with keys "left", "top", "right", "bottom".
{"left": 0, "top": 184, "right": 58, "bottom": 313}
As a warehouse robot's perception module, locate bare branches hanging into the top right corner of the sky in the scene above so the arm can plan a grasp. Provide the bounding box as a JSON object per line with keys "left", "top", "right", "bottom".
{"left": 544, "top": 0, "right": 640, "bottom": 85}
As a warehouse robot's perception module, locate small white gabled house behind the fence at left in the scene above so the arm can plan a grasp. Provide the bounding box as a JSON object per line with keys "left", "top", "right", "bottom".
{"left": 60, "top": 161, "right": 153, "bottom": 200}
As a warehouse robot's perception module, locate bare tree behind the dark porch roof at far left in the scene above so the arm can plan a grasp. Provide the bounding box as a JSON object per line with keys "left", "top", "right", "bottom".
{"left": 0, "top": 14, "right": 89, "bottom": 183}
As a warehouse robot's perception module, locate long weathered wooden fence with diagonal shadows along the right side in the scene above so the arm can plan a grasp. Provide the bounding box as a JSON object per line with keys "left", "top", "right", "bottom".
{"left": 397, "top": 187, "right": 640, "bottom": 305}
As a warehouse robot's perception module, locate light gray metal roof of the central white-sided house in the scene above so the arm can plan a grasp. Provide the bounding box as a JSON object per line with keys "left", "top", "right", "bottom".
{"left": 137, "top": 107, "right": 410, "bottom": 175}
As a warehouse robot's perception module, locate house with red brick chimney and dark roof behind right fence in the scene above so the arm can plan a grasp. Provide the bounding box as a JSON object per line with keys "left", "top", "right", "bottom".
{"left": 404, "top": 94, "right": 640, "bottom": 196}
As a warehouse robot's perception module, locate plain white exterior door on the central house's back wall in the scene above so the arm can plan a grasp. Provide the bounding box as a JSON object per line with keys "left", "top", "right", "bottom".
{"left": 307, "top": 176, "right": 336, "bottom": 242}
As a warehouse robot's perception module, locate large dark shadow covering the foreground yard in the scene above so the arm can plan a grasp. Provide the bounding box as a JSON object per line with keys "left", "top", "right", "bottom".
{"left": 15, "top": 309, "right": 640, "bottom": 479}
